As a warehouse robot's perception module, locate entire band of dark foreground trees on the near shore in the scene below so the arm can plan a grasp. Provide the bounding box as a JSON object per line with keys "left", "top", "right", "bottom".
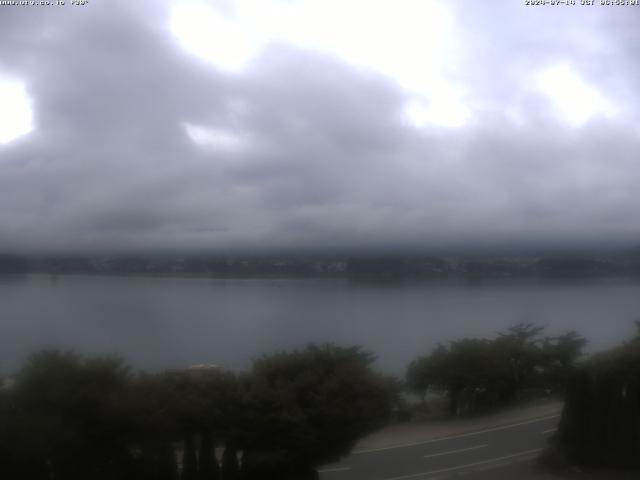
{"left": 0, "top": 323, "right": 640, "bottom": 480}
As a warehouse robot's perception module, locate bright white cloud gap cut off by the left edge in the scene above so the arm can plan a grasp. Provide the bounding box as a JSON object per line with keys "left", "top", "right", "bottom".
{"left": 0, "top": 79, "right": 33, "bottom": 143}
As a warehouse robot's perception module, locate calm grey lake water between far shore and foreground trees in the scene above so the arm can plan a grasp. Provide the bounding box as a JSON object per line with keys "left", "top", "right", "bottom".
{"left": 0, "top": 275, "right": 640, "bottom": 374}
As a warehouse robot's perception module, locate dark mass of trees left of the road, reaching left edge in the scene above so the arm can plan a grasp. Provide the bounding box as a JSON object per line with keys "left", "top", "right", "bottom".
{"left": 0, "top": 346, "right": 393, "bottom": 480}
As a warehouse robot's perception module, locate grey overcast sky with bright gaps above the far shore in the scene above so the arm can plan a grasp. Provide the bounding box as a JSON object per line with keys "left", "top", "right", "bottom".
{"left": 0, "top": 0, "right": 640, "bottom": 251}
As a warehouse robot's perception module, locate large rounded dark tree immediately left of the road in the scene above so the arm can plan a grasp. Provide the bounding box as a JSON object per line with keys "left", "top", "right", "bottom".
{"left": 238, "top": 345, "right": 394, "bottom": 478}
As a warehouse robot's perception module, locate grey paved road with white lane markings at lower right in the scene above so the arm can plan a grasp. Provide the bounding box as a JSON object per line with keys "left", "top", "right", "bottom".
{"left": 319, "top": 415, "right": 559, "bottom": 480}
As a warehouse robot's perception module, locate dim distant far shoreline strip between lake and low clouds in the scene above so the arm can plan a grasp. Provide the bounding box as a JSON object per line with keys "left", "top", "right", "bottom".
{"left": 0, "top": 250, "right": 640, "bottom": 281}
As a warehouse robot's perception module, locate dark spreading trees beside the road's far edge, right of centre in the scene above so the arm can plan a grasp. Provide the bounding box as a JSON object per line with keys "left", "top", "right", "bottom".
{"left": 406, "top": 324, "right": 586, "bottom": 415}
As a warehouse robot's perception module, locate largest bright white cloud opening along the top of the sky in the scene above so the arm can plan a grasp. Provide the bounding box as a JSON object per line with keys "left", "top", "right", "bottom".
{"left": 170, "top": 0, "right": 470, "bottom": 127}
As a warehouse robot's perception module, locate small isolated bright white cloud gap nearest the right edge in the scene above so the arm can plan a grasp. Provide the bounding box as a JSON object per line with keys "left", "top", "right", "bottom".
{"left": 536, "top": 65, "right": 616, "bottom": 127}
